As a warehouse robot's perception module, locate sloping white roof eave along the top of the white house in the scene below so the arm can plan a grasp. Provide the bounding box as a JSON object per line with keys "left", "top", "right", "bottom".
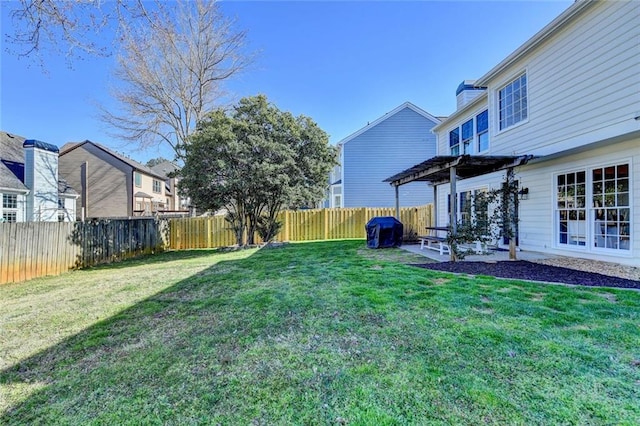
{"left": 475, "top": 0, "right": 597, "bottom": 86}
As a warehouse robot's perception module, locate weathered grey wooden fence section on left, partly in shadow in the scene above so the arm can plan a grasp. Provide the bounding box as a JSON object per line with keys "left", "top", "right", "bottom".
{"left": 0, "top": 218, "right": 167, "bottom": 284}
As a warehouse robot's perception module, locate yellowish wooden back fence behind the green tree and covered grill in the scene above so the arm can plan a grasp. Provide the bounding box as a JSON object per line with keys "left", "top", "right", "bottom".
{"left": 168, "top": 204, "right": 433, "bottom": 250}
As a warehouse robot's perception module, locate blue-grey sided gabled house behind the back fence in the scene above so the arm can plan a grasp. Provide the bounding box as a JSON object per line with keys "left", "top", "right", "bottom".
{"left": 327, "top": 102, "right": 440, "bottom": 207}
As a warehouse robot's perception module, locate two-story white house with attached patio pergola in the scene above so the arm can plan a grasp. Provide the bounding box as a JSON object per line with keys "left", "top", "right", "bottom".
{"left": 389, "top": 1, "right": 640, "bottom": 266}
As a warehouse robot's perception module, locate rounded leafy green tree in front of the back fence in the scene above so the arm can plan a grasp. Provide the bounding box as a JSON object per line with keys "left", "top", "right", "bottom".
{"left": 181, "top": 95, "right": 336, "bottom": 245}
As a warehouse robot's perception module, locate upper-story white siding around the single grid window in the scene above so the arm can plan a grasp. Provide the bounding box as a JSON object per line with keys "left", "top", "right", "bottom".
{"left": 488, "top": 1, "right": 640, "bottom": 155}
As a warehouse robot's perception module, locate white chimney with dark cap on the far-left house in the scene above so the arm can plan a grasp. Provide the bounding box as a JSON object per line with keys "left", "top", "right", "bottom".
{"left": 22, "top": 139, "right": 59, "bottom": 222}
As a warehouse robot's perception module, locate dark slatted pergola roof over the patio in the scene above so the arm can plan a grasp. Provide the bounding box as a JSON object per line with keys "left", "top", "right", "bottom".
{"left": 383, "top": 154, "right": 533, "bottom": 186}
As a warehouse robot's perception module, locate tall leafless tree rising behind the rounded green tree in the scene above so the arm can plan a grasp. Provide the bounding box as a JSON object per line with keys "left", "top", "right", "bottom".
{"left": 102, "top": 0, "right": 249, "bottom": 158}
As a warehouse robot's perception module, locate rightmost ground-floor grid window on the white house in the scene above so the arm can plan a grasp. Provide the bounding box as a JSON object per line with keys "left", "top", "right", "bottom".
{"left": 591, "top": 164, "right": 631, "bottom": 250}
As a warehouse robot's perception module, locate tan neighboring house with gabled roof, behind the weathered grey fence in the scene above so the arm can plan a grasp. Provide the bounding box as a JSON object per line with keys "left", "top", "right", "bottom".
{"left": 59, "top": 141, "right": 168, "bottom": 218}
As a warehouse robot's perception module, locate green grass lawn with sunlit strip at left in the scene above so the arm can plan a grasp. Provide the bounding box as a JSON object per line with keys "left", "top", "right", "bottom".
{"left": 0, "top": 241, "right": 640, "bottom": 425}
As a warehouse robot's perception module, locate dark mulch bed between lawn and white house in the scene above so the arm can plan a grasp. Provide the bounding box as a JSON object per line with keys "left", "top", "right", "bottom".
{"left": 412, "top": 260, "right": 640, "bottom": 289}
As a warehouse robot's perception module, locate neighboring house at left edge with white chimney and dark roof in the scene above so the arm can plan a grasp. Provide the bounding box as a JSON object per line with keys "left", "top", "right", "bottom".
{"left": 0, "top": 132, "right": 78, "bottom": 222}
